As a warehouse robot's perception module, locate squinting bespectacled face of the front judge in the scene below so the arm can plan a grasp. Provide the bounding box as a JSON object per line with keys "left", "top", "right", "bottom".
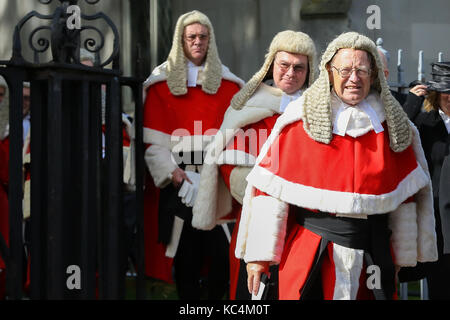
{"left": 328, "top": 49, "right": 373, "bottom": 106}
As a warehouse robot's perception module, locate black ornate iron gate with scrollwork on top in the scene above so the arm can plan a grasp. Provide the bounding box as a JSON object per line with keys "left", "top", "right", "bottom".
{"left": 0, "top": 0, "right": 144, "bottom": 299}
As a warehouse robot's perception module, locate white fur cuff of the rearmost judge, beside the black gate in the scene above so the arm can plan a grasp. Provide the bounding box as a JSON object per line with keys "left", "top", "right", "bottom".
{"left": 145, "top": 145, "right": 178, "bottom": 188}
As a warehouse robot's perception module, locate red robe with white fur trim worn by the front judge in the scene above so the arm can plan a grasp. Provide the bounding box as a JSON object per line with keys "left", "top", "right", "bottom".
{"left": 236, "top": 95, "right": 435, "bottom": 299}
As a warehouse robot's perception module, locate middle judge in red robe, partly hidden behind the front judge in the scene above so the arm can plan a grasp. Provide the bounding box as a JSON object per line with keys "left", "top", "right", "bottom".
{"left": 193, "top": 30, "right": 316, "bottom": 300}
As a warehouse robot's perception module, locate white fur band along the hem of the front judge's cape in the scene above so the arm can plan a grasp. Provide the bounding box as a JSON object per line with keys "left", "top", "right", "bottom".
{"left": 247, "top": 166, "right": 429, "bottom": 215}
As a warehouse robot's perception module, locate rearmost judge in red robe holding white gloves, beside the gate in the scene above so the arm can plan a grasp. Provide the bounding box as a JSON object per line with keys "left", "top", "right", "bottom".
{"left": 144, "top": 11, "right": 244, "bottom": 299}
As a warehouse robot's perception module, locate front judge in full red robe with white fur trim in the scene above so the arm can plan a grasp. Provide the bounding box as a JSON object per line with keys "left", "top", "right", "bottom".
{"left": 235, "top": 32, "right": 437, "bottom": 300}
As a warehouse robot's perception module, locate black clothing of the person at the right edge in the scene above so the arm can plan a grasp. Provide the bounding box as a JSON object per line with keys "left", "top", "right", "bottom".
{"left": 403, "top": 100, "right": 450, "bottom": 299}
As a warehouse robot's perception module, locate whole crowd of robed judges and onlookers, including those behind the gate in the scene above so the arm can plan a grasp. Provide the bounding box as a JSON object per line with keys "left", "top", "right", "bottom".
{"left": 0, "top": 10, "right": 450, "bottom": 300}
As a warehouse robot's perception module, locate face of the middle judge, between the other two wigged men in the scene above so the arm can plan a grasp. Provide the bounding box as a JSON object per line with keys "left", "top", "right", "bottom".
{"left": 273, "top": 51, "right": 308, "bottom": 94}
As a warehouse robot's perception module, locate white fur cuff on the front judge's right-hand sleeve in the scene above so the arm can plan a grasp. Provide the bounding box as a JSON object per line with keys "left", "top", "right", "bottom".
{"left": 389, "top": 202, "right": 417, "bottom": 267}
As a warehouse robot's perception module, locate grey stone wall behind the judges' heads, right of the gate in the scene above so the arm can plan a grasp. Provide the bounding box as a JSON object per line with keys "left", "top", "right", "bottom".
{"left": 170, "top": 0, "right": 450, "bottom": 83}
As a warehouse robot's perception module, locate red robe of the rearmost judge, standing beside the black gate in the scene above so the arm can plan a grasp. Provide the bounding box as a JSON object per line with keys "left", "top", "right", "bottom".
{"left": 144, "top": 79, "right": 240, "bottom": 282}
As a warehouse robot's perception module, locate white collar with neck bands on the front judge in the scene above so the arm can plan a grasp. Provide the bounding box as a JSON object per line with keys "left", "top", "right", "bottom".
{"left": 331, "top": 90, "right": 385, "bottom": 137}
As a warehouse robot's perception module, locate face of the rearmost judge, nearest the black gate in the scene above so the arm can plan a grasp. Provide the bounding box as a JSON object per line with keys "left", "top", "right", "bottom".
{"left": 183, "top": 23, "right": 209, "bottom": 66}
